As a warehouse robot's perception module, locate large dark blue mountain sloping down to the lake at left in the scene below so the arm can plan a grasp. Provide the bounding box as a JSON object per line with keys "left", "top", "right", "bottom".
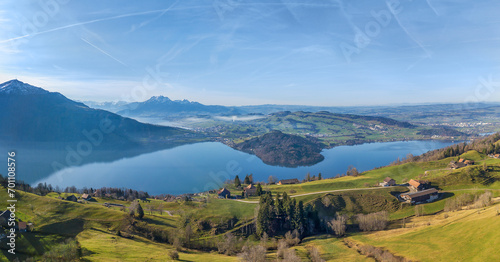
{"left": 0, "top": 80, "right": 191, "bottom": 146}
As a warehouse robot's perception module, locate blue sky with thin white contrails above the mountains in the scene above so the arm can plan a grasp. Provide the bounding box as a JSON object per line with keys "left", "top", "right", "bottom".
{"left": 0, "top": 0, "right": 500, "bottom": 106}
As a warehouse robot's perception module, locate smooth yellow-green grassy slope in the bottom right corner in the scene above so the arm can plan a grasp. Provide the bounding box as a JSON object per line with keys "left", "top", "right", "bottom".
{"left": 352, "top": 201, "right": 500, "bottom": 261}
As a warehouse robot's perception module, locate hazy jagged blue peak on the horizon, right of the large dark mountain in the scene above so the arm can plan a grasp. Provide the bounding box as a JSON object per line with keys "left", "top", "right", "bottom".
{"left": 117, "top": 96, "right": 240, "bottom": 117}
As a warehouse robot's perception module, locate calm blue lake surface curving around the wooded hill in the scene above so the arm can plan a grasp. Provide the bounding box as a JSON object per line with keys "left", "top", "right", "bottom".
{"left": 18, "top": 141, "right": 460, "bottom": 194}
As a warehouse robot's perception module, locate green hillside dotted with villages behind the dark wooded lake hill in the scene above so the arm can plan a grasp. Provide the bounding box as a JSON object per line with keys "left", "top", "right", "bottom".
{"left": 199, "top": 111, "right": 466, "bottom": 148}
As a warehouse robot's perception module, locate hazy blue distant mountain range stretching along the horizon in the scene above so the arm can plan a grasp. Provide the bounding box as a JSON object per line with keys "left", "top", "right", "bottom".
{"left": 84, "top": 96, "right": 500, "bottom": 132}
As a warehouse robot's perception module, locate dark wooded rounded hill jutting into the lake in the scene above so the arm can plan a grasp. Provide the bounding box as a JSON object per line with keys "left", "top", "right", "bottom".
{"left": 234, "top": 130, "right": 324, "bottom": 167}
